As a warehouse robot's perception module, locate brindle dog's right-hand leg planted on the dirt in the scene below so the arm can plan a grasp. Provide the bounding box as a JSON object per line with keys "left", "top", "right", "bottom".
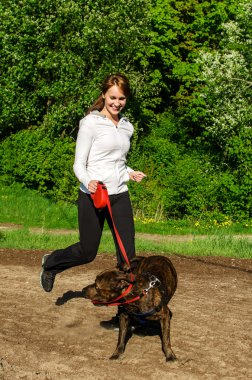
{"left": 160, "top": 306, "right": 176, "bottom": 362}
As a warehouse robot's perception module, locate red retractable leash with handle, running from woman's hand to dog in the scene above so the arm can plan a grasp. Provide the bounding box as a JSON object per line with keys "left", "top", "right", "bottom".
{"left": 91, "top": 182, "right": 136, "bottom": 306}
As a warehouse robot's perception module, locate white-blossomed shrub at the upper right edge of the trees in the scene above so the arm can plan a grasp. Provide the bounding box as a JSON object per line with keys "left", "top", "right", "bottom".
{"left": 198, "top": 3, "right": 252, "bottom": 148}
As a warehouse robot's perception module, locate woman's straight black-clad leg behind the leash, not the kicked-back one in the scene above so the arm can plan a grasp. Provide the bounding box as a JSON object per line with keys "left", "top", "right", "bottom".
{"left": 106, "top": 191, "right": 135, "bottom": 265}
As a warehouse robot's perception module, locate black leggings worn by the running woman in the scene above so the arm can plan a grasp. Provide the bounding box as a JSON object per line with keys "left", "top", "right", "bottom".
{"left": 44, "top": 190, "right": 135, "bottom": 274}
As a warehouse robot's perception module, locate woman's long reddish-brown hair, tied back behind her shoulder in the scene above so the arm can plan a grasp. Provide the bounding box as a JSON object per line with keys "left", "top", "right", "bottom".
{"left": 86, "top": 73, "right": 130, "bottom": 115}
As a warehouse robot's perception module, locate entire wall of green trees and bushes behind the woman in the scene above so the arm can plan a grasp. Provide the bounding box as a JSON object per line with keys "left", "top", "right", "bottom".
{"left": 0, "top": 0, "right": 252, "bottom": 220}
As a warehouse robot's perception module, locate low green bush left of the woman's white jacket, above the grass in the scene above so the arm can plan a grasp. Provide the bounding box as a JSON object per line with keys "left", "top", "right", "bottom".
{"left": 0, "top": 128, "right": 78, "bottom": 201}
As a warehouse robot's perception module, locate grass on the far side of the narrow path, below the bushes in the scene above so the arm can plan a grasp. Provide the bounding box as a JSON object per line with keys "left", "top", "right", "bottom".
{"left": 0, "top": 179, "right": 252, "bottom": 235}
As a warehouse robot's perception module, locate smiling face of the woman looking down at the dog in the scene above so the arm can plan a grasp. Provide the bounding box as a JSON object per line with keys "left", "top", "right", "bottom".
{"left": 102, "top": 85, "right": 127, "bottom": 119}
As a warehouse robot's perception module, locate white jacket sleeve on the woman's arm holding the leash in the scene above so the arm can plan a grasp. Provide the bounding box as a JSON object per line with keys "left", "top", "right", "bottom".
{"left": 73, "top": 117, "right": 95, "bottom": 188}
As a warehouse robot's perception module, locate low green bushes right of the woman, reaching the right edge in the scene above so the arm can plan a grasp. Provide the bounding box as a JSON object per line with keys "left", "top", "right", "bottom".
{"left": 130, "top": 110, "right": 252, "bottom": 221}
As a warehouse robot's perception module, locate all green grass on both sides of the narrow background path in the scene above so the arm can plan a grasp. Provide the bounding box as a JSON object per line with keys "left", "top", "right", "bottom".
{"left": 0, "top": 182, "right": 252, "bottom": 258}
